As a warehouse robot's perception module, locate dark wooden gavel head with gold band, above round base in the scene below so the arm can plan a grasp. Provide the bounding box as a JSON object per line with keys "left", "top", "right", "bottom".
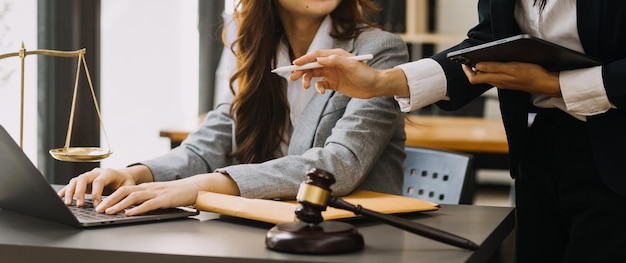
{"left": 295, "top": 168, "right": 335, "bottom": 224}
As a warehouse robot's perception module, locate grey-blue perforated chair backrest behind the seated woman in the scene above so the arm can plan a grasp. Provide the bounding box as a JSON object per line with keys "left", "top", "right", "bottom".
{"left": 403, "top": 146, "right": 476, "bottom": 204}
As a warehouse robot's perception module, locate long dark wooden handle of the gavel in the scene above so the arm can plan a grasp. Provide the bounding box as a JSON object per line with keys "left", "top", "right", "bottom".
{"left": 328, "top": 196, "right": 479, "bottom": 250}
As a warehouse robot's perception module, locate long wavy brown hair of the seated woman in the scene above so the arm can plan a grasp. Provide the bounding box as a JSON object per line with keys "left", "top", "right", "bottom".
{"left": 223, "top": 0, "right": 378, "bottom": 163}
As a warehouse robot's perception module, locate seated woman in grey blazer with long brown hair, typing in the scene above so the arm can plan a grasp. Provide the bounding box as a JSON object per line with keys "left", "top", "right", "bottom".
{"left": 59, "top": 0, "right": 408, "bottom": 218}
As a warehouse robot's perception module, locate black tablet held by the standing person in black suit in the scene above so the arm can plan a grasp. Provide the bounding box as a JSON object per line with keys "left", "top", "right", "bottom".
{"left": 447, "top": 34, "right": 601, "bottom": 71}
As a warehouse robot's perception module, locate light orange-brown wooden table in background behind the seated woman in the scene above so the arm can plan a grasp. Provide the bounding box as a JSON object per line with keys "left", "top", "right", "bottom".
{"left": 159, "top": 115, "right": 509, "bottom": 169}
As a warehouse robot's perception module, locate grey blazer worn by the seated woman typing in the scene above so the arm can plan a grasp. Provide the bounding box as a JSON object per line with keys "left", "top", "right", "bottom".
{"left": 142, "top": 29, "right": 408, "bottom": 198}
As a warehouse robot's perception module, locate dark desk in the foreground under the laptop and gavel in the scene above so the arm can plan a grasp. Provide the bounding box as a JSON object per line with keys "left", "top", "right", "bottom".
{"left": 0, "top": 189, "right": 515, "bottom": 263}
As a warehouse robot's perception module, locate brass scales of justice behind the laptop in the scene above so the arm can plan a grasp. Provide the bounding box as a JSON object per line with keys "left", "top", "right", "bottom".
{"left": 0, "top": 43, "right": 113, "bottom": 162}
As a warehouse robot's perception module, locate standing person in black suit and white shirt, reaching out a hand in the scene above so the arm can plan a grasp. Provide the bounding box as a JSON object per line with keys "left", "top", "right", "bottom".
{"left": 290, "top": 0, "right": 626, "bottom": 262}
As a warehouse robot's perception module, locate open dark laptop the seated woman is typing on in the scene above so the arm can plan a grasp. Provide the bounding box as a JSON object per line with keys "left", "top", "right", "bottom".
{"left": 0, "top": 125, "right": 198, "bottom": 228}
